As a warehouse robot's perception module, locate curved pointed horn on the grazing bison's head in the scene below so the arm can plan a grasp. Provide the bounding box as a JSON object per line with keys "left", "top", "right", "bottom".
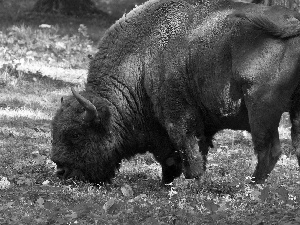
{"left": 71, "top": 87, "right": 98, "bottom": 122}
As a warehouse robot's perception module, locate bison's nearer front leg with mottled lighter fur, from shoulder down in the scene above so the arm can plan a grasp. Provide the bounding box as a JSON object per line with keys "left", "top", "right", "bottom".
{"left": 149, "top": 79, "right": 206, "bottom": 179}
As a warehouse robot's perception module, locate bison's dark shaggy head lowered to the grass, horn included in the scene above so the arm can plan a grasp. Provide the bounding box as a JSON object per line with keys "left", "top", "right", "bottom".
{"left": 51, "top": 89, "right": 121, "bottom": 183}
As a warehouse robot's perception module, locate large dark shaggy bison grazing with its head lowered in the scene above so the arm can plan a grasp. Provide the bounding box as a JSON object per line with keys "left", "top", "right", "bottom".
{"left": 51, "top": 0, "right": 300, "bottom": 183}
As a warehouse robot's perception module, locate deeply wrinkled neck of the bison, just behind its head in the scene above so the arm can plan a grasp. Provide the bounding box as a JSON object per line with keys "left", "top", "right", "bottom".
{"left": 86, "top": 65, "right": 150, "bottom": 154}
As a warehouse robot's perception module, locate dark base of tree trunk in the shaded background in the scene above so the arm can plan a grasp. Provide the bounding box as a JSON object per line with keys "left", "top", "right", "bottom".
{"left": 33, "top": 0, "right": 108, "bottom": 16}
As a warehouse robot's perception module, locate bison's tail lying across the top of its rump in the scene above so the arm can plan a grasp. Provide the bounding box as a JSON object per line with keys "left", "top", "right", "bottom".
{"left": 231, "top": 13, "right": 300, "bottom": 39}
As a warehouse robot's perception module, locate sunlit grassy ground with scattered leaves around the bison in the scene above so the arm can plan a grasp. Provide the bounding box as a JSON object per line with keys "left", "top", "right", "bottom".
{"left": 0, "top": 0, "right": 300, "bottom": 225}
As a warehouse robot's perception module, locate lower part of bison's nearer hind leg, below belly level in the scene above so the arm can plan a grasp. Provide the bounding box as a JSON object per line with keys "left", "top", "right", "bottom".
{"left": 246, "top": 98, "right": 283, "bottom": 183}
